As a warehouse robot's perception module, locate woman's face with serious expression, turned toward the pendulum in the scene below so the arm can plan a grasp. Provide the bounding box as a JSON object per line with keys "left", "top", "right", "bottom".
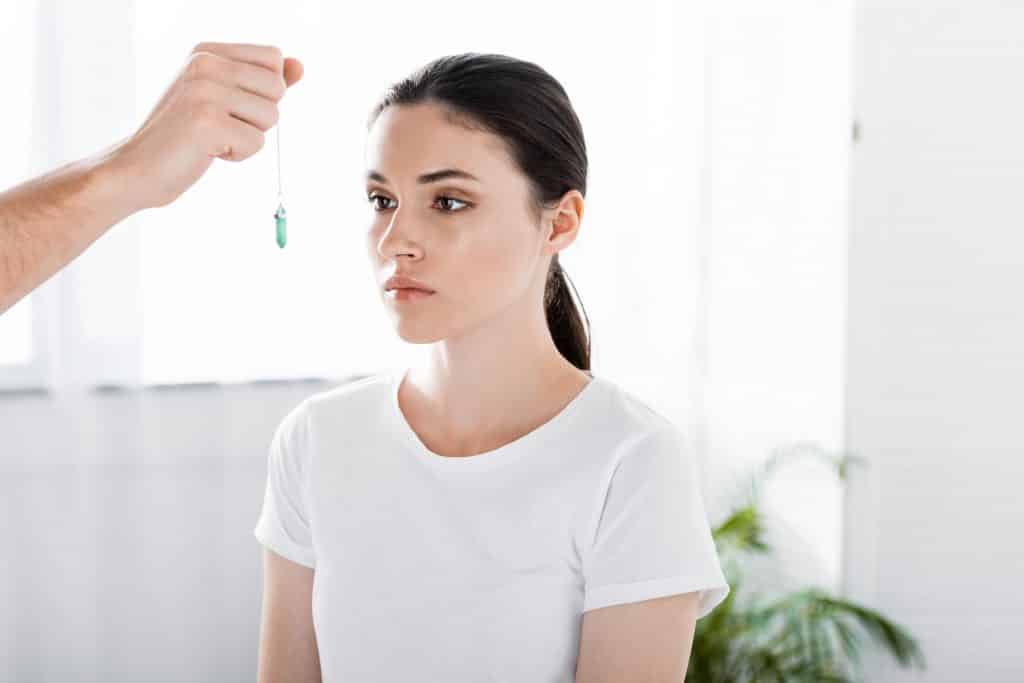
{"left": 366, "top": 103, "right": 557, "bottom": 343}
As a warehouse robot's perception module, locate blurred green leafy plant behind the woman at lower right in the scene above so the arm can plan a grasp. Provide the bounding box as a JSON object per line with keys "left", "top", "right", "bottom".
{"left": 686, "top": 446, "right": 926, "bottom": 683}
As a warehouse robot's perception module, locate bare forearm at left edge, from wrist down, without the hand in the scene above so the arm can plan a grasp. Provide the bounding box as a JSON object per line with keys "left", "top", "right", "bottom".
{"left": 0, "top": 145, "right": 137, "bottom": 314}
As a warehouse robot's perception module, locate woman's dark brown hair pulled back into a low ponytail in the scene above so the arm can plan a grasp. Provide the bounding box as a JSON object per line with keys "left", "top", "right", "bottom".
{"left": 367, "top": 52, "right": 591, "bottom": 371}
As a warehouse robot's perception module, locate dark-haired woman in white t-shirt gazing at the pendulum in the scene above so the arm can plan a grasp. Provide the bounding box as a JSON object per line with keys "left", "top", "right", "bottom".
{"left": 255, "top": 53, "right": 729, "bottom": 683}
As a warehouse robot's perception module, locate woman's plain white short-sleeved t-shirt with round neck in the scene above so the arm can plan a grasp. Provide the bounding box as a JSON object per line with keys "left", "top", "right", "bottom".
{"left": 254, "top": 370, "right": 729, "bottom": 683}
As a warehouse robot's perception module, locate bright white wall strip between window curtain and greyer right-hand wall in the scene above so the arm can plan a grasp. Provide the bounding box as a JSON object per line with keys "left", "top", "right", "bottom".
{"left": 693, "top": 0, "right": 853, "bottom": 592}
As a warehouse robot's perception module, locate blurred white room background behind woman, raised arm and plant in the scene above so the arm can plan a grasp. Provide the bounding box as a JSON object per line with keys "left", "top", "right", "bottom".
{"left": 0, "top": 0, "right": 1024, "bottom": 682}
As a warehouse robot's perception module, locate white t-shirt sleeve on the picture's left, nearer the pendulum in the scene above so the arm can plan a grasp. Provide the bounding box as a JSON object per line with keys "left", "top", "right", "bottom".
{"left": 253, "top": 402, "right": 316, "bottom": 568}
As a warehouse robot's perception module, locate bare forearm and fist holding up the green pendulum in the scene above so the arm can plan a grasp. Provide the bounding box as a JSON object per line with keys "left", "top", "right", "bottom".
{"left": 0, "top": 43, "right": 302, "bottom": 313}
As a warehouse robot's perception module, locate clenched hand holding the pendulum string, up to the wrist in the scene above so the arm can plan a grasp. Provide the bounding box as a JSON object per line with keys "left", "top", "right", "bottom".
{"left": 110, "top": 43, "right": 303, "bottom": 210}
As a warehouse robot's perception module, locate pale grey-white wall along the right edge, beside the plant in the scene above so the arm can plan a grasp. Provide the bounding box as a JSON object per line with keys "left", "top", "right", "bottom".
{"left": 847, "top": 0, "right": 1024, "bottom": 683}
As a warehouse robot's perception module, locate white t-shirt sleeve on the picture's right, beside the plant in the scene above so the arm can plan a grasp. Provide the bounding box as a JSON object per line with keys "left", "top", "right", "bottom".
{"left": 583, "top": 425, "right": 729, "bottom": 618}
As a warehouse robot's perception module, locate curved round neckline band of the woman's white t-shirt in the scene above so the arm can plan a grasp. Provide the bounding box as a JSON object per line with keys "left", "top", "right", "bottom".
{"left": 388, "top": 368, "right": 604, "bottom": 470}
